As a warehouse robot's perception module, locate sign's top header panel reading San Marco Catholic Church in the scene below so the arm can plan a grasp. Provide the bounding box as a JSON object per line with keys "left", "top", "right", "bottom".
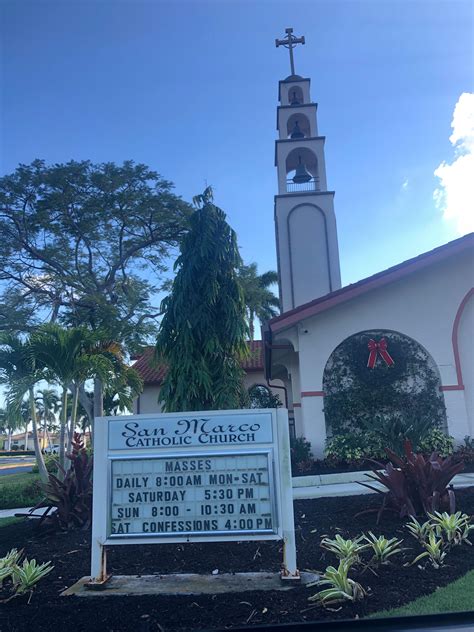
{"left": 109, "top": 414, "right": 273, "bottom": 450}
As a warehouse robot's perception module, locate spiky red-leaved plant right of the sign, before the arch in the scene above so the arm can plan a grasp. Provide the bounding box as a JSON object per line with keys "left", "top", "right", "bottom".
{"left": 360, "top": 440, "right": 464, "bottom": 522}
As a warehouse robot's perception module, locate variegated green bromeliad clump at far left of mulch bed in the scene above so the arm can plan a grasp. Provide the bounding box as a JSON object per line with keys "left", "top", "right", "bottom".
{"left": 0, "top": 549, "right": 54, "bottom": 603}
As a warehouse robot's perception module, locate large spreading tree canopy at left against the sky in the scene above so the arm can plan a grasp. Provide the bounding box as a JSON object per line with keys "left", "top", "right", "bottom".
{"left": 0, "top": 160, "right": 192, "bottom": 352}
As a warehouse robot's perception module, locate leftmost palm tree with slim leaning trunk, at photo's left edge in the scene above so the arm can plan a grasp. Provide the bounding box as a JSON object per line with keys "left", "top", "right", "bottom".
{"left": 0, "top": 333, "right": 48, "bottom": 481}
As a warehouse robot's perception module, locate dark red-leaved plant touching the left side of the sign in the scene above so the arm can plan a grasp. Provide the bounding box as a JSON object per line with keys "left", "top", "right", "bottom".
{"left": 31, "top": 432, "right": 93, "bottom": 530}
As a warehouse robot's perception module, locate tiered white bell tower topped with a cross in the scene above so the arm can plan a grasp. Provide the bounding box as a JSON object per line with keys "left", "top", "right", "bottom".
{"left": 275, "top": 28, "right": 341, "bottom": 312}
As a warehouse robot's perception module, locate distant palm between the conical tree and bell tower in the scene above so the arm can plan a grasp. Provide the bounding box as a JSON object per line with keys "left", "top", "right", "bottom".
{"left": 238, "top": 263, "right": 280, "bottom": 340}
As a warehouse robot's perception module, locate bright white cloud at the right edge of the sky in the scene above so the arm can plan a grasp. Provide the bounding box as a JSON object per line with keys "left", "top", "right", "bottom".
{"left": 433, "top": 92, "right": 474, "bottom": 235}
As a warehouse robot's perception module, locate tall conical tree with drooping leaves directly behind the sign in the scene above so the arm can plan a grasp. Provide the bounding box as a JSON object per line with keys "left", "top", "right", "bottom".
{"left": 156, "top": 188, "right": 248, "bottom": 412}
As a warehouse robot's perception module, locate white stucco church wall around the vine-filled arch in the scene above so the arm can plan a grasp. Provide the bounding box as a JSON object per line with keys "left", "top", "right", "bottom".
{"left": 276, "top": 252, "right": 474, "bottom": 455}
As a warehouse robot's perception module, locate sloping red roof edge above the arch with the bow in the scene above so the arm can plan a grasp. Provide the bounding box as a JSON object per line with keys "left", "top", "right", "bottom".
{"left": 268, "top": 233, "right": 474, "bottom": 333}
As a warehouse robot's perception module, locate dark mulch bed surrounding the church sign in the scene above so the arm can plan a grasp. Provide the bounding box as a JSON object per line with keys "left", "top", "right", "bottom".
{"left": 0, "top": 487, "right": 474, "bottom": 632}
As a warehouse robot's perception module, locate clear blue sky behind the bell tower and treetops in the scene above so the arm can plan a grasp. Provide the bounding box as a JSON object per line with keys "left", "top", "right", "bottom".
{"left": 0, "top": 0, "right": 474, "bottom": 284}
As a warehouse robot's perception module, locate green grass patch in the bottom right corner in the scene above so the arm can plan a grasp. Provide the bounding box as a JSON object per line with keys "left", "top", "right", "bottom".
{"left": 371, "top": 571, "right": 474, "bottom": 618}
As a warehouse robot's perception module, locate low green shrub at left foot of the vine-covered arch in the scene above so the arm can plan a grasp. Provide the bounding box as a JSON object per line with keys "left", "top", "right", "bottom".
{"left": 324, "top": 432, "right": 385, "bottom": 463}
